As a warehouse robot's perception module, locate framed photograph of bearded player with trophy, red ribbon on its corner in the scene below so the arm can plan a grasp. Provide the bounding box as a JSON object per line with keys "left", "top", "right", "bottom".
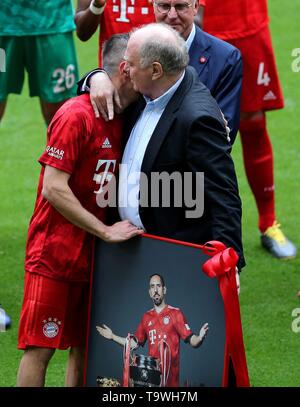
{"left": 86, "top": 235, "right": 249, "bottom": 387}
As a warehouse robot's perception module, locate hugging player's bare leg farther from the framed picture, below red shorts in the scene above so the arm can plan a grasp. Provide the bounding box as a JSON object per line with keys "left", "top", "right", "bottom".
{"left": 17, "top": 347, "right": 55, "bottom": 387}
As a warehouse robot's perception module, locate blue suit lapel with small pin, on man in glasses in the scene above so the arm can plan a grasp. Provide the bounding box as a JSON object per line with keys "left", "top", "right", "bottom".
{"left": 189, "top": 26, "right": 210, "bottom": 75}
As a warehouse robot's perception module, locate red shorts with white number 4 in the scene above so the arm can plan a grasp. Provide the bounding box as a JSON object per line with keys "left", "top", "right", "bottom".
{"left": 228, "top": 26, "right": 284, "bottom": 112}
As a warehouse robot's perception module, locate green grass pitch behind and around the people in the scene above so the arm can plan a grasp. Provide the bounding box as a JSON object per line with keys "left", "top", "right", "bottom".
{"left": 0, "top": 0, "right": 300, "bottom": 387}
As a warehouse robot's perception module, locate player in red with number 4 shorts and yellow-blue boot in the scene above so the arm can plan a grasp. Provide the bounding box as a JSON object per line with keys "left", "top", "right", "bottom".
{"left": 200, "top": 0, "right": 297, "bottom": 259}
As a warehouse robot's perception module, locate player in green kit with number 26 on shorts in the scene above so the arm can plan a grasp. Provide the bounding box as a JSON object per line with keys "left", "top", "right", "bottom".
{"left": 0, "top": 0, "right": 78, "bottom": 124}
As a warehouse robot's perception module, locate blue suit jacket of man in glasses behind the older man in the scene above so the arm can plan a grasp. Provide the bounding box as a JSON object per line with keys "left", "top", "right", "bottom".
{"left": 189, "top": 26, "right": 242, "bottom": 144}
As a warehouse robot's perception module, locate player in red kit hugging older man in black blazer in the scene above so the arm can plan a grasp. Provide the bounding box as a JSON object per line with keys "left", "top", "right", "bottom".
{"left": 17, "top": 34, "right": 142, "bottom": 387}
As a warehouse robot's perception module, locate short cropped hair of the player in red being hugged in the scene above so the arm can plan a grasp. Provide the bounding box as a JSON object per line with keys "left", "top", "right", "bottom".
{"left": 102, "top": 33, "right": 129, "bottom": 75}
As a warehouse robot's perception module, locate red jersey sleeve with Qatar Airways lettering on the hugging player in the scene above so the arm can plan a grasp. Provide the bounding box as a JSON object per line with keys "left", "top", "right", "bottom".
{"left": 39, "top": 99, "right": 90, "bottom": 174}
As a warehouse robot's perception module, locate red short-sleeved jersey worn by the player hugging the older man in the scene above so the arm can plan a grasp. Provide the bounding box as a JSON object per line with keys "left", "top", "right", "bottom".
{"left": 25, "top": 95, "right": 122, "bottom": 281}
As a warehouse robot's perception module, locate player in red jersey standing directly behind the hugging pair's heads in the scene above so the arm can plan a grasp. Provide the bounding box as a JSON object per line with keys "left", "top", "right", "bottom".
{"left": 75, "top": 0, "right": 204, "bottom": 66}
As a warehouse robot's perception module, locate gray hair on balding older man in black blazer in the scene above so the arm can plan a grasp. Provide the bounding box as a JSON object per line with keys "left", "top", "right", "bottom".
{"left": 139, "top": 23, "right": 189, "bottom": 75}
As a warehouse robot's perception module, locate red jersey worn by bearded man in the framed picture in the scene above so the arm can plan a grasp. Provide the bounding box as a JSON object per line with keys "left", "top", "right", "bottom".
{"left": 135, "top": 305, "right": 193, "bottom": 387}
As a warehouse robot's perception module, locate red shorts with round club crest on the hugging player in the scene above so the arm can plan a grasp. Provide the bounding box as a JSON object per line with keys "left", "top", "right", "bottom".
{"left": 18, "top": 272, "right": 89, "bottom": 349}
